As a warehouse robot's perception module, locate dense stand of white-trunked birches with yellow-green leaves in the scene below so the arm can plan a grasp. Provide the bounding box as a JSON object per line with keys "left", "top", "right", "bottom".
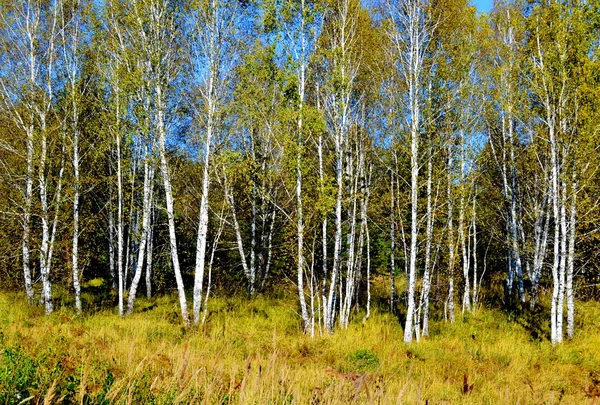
{"left": 0, "top": 0, "right": 600, "bottom": 344}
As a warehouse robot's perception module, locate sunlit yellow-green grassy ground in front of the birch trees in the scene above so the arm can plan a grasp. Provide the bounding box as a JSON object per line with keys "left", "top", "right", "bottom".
{"left": 0, "top": 280, "right": 600, "bottom": 404}
